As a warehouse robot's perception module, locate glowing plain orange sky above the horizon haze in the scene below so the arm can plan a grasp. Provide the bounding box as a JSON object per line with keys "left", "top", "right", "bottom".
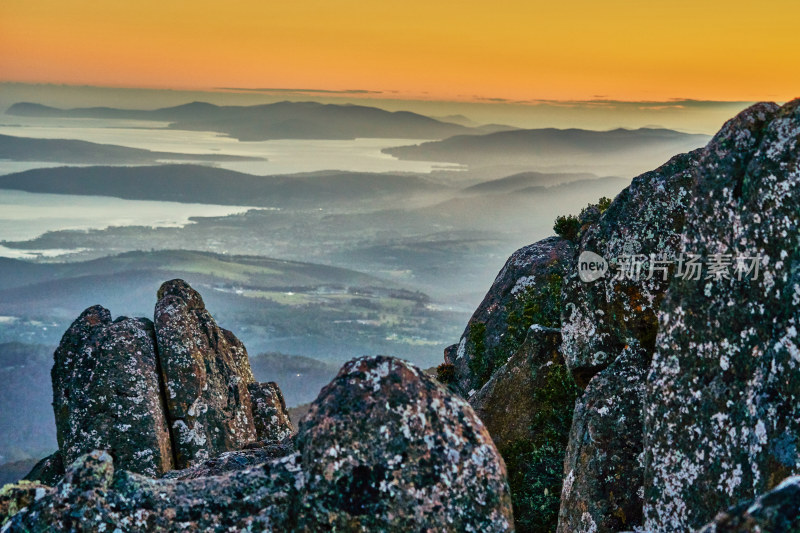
{"left": 0, "top": 0, "right": 800, "bottom": 101}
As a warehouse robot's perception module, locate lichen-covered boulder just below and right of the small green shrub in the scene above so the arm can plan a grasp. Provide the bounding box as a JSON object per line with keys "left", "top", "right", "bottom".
{"left": 561, "top": 152, "right": 697, "bottom": 387}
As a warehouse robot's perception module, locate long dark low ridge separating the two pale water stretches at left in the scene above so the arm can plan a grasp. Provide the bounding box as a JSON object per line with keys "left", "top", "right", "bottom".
{"left": 0, "top": 165, "right": 441, "bottom": 207}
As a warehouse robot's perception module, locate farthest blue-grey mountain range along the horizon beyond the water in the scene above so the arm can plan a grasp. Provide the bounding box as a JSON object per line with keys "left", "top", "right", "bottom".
{"left": 6, "top": 102, "right": 513, "bottom": 141}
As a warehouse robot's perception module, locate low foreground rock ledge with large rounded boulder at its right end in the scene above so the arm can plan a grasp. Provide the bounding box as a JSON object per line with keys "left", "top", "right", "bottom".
{"left": 0, "top": 356, "right": 513, "bottom": 532}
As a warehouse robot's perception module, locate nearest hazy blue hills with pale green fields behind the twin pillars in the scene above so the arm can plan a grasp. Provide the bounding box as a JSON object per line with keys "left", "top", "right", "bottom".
{"left": 0, "top": 250, "right": 463, "bottom": 361}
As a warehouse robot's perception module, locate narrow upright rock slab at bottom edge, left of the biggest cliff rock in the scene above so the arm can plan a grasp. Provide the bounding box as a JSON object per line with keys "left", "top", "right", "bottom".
{"left": 558, "top": 344, "right": 649, "bottom": 533}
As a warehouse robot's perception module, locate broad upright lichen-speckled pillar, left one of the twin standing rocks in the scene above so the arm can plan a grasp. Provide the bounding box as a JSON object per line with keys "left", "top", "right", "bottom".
{"left": 52, "top": 306, "right": 173, "bottom": 476}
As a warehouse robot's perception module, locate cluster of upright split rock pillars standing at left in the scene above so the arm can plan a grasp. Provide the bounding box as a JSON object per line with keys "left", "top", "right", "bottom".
{"left": 26, "top": 280, "right": 293, "bottom": 485}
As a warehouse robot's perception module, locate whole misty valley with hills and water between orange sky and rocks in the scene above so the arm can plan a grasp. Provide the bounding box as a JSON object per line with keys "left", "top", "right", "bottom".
{"left": 0, "top": 97, "right": 709, "bottom": 483}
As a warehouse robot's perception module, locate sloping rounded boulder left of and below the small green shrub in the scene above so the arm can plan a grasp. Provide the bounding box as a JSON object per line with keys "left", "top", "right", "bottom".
{"left": 445, "top": 237, "right": 573, "bottom": 397}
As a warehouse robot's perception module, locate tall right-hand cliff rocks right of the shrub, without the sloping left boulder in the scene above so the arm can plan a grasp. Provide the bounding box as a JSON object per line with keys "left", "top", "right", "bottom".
{"left": 548, "top": 103, "right": 800, "bottom": 531}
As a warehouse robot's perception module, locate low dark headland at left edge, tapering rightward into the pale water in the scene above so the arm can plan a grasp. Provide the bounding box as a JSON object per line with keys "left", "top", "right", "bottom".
{"left": 0, "top": 135, "right": 264, "bottom": 164}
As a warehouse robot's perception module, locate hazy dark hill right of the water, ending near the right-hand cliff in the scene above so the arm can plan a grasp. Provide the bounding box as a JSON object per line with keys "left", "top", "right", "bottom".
{"left": 383, "top": 128, "right": 709, "bottom": 175}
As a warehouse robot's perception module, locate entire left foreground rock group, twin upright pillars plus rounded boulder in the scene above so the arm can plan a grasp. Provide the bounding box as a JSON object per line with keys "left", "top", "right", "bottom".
{"left": 0, "top": 280, "right": 513, "bottom": 533}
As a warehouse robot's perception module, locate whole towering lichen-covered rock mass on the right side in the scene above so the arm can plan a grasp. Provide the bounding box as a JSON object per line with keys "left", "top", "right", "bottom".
{"left": 445, "top": 97, "right": 800, "bottom": 533}
